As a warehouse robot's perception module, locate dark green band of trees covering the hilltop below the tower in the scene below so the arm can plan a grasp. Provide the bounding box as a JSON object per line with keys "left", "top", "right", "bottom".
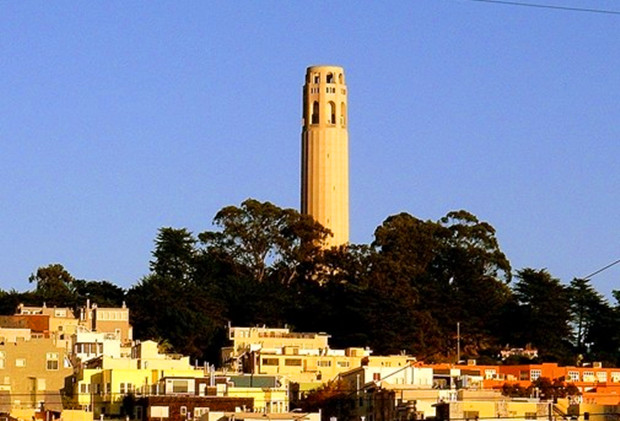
{"left": 0, "top": 199, "right": 620, "bottom": 365}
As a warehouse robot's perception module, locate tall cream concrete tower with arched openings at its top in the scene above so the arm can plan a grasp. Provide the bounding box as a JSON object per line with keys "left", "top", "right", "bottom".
{"left": 301, "top": 66, "right": 349, "bottom": 247}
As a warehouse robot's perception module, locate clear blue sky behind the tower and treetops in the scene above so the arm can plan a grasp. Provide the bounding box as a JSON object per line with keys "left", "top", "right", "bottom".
{"left": 0, "top": 0, "right": 620, "bottom": 294}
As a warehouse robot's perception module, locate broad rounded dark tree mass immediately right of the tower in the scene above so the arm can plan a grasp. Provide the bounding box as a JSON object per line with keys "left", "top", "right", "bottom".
{"left": 370, "top": 210, "right": 510, "bottom": 359}
